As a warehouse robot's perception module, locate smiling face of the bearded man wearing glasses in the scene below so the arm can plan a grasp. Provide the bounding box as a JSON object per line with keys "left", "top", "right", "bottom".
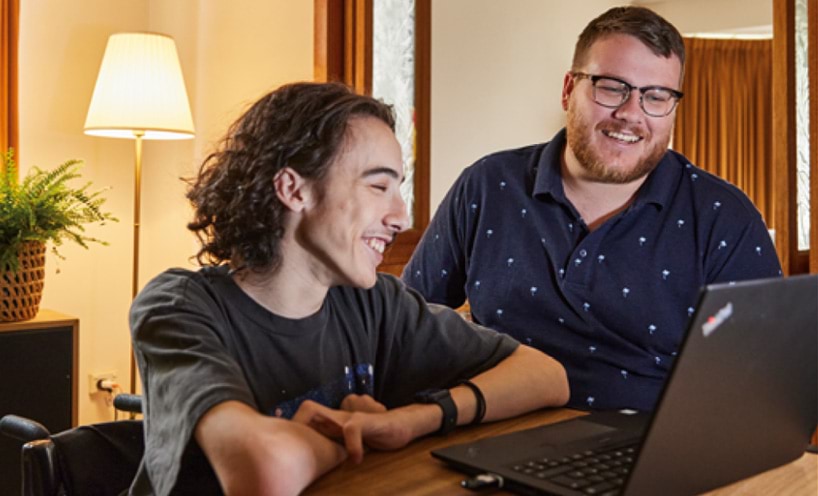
{"left": 562, "top": 34, "right": 682, "bottom": 184}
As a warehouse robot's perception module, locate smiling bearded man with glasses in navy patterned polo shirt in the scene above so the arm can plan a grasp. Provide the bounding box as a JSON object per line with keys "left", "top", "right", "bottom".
{"left": 403, "top": 6, "right": 781, "bottom": 411}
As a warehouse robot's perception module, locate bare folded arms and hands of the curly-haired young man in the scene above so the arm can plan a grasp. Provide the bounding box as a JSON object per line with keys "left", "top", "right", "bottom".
{"left": 196, "top": 345, "right": 568, "bottom": 495}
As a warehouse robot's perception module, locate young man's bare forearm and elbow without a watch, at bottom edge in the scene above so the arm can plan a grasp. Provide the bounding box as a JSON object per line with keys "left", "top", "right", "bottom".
{"left": 196, "top": 402, "right": 346, "bottom": 495}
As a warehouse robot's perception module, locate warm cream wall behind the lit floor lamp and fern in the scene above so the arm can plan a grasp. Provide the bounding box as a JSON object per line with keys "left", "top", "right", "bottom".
{"left": 19, "top": 0, "right": 313, "bottom": 423}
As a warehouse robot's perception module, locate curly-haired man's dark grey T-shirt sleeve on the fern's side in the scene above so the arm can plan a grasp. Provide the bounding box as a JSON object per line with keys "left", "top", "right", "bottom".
{"left": 130, "top": 271, "right": 255, "bottom": 495}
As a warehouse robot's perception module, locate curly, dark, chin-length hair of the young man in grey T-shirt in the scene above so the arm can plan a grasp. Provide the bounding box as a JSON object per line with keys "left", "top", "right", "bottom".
{"left": 187, "top": 82, "right": 395, "bottom": 273}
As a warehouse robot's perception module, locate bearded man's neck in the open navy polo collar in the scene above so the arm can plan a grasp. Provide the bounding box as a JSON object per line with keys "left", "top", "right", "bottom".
{"left": 560, "top": 147, "right": 647, "bottom": 231}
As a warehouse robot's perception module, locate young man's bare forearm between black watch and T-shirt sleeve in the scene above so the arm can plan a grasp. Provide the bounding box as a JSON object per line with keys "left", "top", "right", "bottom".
{"left": 451, "top": 345, "right": 569, "bottom": 425}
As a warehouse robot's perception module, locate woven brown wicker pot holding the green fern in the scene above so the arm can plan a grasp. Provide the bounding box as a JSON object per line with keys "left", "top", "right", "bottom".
{"left": 0, "top": 241, "right": 45, "bottom": 322}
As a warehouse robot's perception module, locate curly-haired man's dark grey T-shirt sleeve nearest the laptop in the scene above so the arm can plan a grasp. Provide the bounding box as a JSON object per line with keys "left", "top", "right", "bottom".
{"left": 372, "top": 275, "right": 519, "bottom": 407}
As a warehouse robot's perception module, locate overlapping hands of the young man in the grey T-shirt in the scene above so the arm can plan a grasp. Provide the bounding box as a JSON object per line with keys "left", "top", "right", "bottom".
{"left": 292, "top": 397, "right": 415, "bottom": 463}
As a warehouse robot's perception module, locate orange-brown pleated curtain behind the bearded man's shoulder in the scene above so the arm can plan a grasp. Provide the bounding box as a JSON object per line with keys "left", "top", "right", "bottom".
{"left": 673, "top": 38, "right": 775, "bottom": 228}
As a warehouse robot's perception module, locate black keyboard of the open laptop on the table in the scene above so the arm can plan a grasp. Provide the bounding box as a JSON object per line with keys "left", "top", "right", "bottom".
{"left": 504, "top": 444, "right": 639, "bottom": 496}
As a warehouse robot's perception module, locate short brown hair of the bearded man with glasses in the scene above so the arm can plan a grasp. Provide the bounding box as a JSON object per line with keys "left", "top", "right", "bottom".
{"left": 572, "top": 6, "right": 685, "bottom": 76}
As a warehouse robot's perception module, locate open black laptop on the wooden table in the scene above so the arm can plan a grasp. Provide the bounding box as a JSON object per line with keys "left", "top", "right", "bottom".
{"left": 432, "top": 275, "right": 818, "bottom": 495}
